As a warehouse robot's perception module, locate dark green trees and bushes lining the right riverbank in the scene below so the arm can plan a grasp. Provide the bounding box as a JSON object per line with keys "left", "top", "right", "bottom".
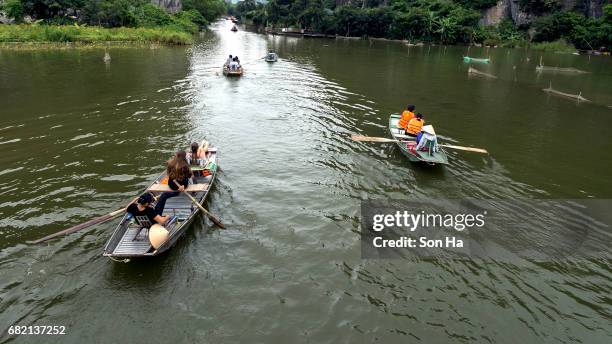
{"left": 230, "top": 0, "right": 612, "bottom": 50}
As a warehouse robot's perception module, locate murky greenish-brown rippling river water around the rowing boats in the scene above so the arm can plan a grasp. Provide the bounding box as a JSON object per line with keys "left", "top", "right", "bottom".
{"left": 0, "top": 22, "right": 612, "bottom": 343}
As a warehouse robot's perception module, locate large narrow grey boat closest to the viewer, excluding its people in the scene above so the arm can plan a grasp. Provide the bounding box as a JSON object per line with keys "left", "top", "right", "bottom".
{"left": 102, "top": 148, "right": 218, "bottom": 261}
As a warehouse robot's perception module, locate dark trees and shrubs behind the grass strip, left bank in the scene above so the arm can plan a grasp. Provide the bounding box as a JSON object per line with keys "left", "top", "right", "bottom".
{"left": 2, "top": 0, "right": 225, "bottom": 32}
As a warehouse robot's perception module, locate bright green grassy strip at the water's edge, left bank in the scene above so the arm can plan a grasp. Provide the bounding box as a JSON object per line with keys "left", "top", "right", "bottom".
{"left": 0, "top": 24, "right": 193, "bottom": 44}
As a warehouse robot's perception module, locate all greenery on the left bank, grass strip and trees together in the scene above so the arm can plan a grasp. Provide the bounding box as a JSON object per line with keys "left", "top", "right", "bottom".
{"left": 0, "top": 0, "right": 225, "bottom": 44}
